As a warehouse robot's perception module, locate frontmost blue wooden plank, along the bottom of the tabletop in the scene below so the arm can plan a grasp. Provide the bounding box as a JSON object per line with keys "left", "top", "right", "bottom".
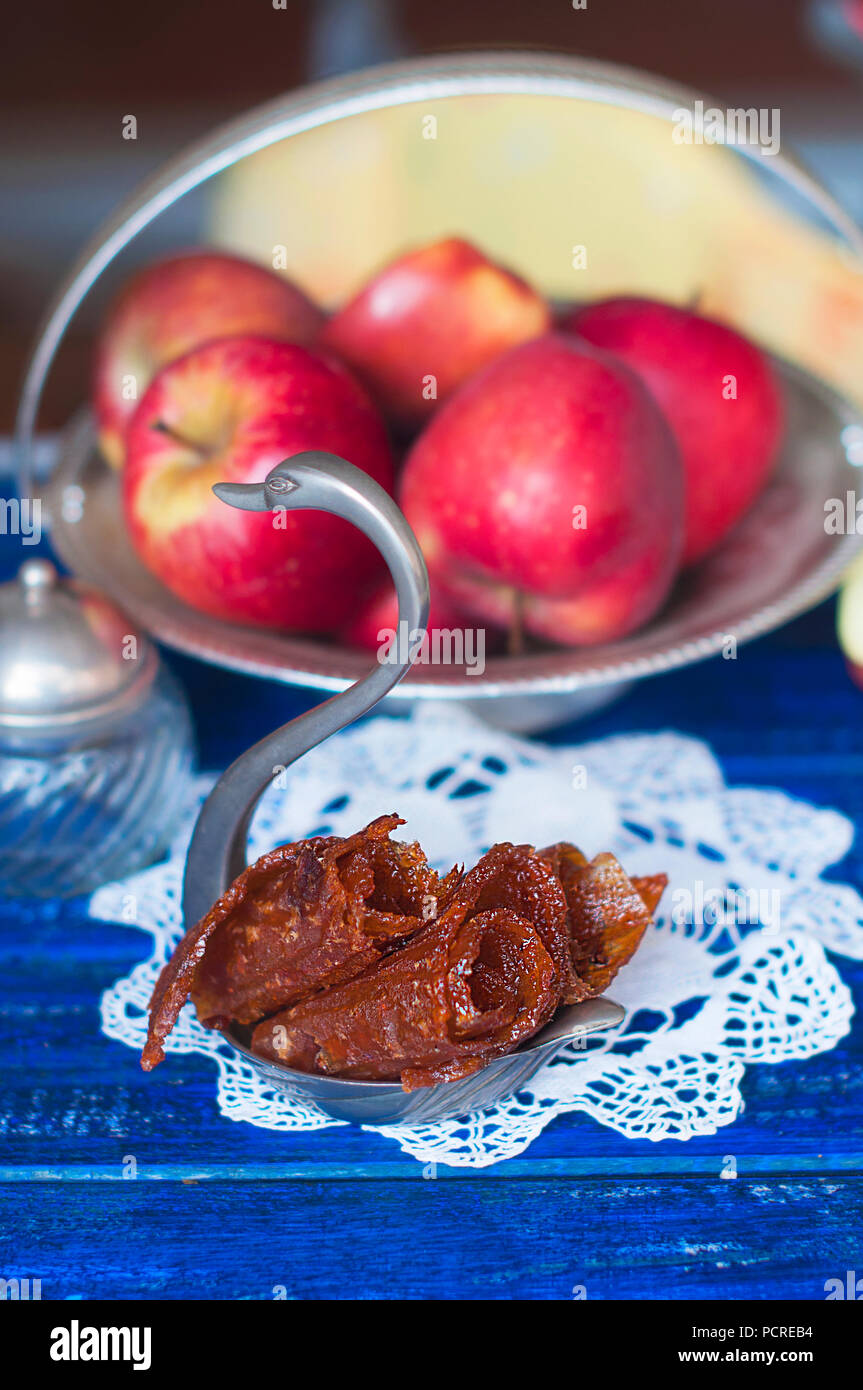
{"left": 0, "top": 1179, "right": 863, "bottom": 1300}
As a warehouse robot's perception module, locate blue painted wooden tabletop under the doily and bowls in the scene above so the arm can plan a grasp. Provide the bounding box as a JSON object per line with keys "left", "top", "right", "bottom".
{"left": 0, "top": 522, "right": 863, "bottom": 1300}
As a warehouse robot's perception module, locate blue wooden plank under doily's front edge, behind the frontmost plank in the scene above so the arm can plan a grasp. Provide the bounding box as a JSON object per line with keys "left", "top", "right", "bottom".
{"left": 0, "top": 905, "right": 863, "bottom": 1176}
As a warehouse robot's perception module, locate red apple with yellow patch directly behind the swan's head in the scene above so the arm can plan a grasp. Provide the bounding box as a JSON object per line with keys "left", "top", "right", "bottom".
{"left": 124, "top": 338, "right": 393, "bottom": 632}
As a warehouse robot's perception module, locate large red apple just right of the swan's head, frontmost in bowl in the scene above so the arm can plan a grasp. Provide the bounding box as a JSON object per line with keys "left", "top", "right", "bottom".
{"left": 402, "top": 334, "right": 684, "bottom": 645}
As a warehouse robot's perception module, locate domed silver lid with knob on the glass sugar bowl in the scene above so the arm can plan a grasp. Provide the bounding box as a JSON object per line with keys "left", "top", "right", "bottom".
{"left": 0, "top": 559, "right": 158, "bottom": 733}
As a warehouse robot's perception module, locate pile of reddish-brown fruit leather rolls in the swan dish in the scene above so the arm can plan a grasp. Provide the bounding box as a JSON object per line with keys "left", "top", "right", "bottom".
{"left": 142, "top": 816, "right": 666, "bottom": 1090}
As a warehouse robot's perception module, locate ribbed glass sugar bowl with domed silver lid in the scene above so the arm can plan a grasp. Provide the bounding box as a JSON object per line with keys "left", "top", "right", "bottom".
{"left": 0, "top": 559, "right": 193, "bottom": 898}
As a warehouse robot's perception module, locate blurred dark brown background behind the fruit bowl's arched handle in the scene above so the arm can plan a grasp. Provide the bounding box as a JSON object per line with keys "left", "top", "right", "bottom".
{"left": 0, "top": 0, "right": 863, "bottom": 432}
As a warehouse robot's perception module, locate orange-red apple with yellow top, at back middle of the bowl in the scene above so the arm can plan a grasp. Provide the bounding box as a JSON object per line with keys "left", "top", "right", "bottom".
{"left": 322, "top": 238, "right": 549, "bottom": 427}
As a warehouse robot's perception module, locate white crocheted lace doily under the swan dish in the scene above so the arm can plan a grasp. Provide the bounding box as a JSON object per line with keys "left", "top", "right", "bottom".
{"left": 90, "top": 705, "right": 863, "bottom": 1168}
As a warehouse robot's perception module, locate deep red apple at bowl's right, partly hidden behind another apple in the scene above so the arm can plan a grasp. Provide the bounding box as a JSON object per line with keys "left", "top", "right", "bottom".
{"left": 566, "top": 299, "right": 784, "bottom": 564}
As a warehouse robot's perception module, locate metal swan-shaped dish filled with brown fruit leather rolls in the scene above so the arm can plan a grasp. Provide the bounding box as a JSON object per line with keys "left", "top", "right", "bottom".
{"left": 142, "top": 452, "right": 655, "bottom": 1123}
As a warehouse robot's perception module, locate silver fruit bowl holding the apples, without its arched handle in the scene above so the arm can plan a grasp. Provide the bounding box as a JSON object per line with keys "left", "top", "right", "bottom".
{"left": 49, "top": 353, "right": 863, "bottom": 730}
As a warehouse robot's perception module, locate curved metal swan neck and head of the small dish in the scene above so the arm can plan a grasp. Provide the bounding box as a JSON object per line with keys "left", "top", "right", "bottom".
{"left": 183, "top": 452, "right": 428, "bottom": 927}
